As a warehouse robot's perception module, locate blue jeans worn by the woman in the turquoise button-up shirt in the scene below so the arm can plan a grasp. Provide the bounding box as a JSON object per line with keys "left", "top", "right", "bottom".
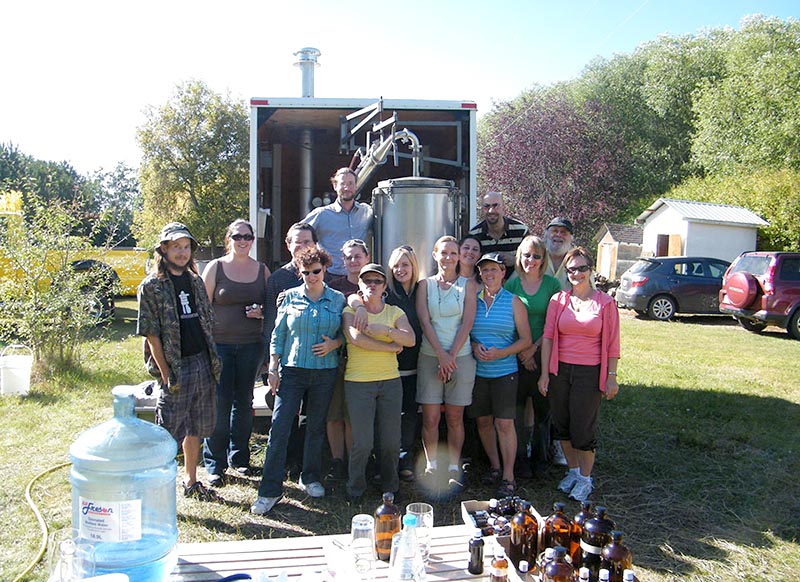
{"left": 258, "top": 367, "right": 336, "bottom": 497}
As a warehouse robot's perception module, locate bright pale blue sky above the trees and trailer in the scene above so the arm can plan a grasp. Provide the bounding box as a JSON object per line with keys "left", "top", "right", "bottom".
{"left": 0, "top": 0, "right": 800, "bottom": 172}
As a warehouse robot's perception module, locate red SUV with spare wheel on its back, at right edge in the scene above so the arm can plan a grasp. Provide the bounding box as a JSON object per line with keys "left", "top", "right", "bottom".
{"left": 719, "top": 251, "right": 800, "bottom": 339}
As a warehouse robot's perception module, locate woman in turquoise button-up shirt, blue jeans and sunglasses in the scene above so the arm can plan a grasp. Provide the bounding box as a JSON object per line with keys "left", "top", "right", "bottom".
{"left": 250, "top": 246, "right": 345, "bottom": 515}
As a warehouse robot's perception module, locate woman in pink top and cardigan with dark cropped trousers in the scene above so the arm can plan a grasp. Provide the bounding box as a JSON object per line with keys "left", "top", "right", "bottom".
{"left": 539, "top": 247, "right": 620, "bottom": 501}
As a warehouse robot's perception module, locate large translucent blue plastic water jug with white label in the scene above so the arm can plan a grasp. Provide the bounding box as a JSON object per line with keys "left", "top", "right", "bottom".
{"left": 69, "top": 386, "right": 178, "bottom": 582}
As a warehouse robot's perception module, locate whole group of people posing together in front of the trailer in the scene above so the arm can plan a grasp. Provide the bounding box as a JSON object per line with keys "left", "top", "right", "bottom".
{"left": 138, "top": 168, "right": 619, "bottom": 514}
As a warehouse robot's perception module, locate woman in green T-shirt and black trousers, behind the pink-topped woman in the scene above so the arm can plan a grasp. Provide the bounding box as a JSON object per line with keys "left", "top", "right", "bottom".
{"left": 505, "top": 235, "right": 561, "bottom": 479}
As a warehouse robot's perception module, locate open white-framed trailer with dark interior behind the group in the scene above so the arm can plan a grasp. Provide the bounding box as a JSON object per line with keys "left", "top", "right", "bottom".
{"left": 250, "top": 97, "right": 477, "bottom": 268}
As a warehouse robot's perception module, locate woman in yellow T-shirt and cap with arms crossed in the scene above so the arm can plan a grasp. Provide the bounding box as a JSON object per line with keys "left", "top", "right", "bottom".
{"left": 342, "top": 263, "right": 416, "bottom": 502}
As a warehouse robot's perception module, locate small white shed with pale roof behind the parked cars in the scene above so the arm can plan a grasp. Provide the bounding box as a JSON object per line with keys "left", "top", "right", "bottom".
{"left": 636, "top": 198, "right": 769, "bottom": 261}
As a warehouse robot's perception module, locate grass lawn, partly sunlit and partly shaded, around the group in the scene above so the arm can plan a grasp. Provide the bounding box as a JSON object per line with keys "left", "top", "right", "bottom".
{"left": 0, "top": 300, "right": 800, "bottom": 582}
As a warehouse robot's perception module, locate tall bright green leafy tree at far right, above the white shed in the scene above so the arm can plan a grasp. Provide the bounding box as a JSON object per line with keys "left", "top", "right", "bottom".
{"left": 692, "top": 16, "right": 800, "bottom": 174}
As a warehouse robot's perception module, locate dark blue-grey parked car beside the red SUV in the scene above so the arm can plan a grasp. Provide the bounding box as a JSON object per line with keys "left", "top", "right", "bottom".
{"left": 616, "top": 257, "right": 730, "bottom": 321}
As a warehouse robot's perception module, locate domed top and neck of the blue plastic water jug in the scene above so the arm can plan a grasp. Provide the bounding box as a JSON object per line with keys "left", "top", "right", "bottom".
{"left": 69, "top": 386, "right": 178, "bottom": 471}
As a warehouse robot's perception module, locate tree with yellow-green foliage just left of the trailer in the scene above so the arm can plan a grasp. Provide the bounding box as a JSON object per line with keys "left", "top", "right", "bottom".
{"left": 133, "top": 81, "right": 249, "bottom": 252}
